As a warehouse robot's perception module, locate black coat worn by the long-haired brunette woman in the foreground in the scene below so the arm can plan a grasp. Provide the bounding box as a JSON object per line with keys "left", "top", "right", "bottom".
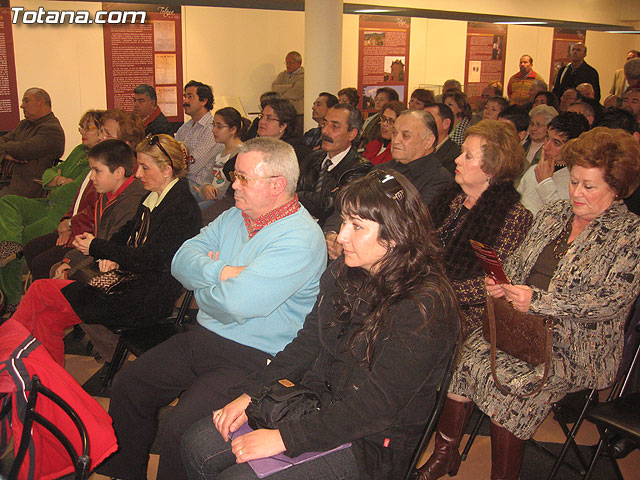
{"left": 241, "top": 261, "right": 459, "bottom": 480}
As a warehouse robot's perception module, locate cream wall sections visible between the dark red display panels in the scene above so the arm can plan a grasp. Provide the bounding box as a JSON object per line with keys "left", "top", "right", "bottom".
{"left": 7, "top": 0, "right": 640, "bottom": 158}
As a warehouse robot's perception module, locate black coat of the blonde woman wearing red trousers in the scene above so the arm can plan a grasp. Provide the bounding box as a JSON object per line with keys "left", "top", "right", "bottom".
{"left": 62, "top": 179, "right": 202, "bottom": 327}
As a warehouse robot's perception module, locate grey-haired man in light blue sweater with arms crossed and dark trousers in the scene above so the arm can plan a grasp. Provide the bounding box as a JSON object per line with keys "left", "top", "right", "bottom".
{"left": 99, "top": 137, "right": 327, "bottom": 480}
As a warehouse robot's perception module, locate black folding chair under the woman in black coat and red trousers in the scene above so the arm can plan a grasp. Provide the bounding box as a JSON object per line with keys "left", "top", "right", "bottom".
{"left": 102, "top": 290, "right": 193, "bottom": 389}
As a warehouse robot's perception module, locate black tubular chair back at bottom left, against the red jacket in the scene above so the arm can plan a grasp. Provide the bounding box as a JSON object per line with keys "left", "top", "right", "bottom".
{"left": 8, "top": 375, "right": 91, "bottom": 480}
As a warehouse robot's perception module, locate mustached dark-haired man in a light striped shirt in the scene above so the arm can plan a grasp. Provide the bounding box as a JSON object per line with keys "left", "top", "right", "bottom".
{"left": 176, "top": 80, "right": 224, "bottom": 206}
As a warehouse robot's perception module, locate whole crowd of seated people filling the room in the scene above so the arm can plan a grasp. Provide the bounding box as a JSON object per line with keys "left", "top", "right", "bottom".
{"left": 0, "top": 50, "right": 640, "bottom": 480}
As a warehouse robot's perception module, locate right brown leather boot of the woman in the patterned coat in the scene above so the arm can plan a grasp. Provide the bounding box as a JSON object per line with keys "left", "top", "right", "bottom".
{"left": 491, "top": 422, "right": 525, "bottom": 480}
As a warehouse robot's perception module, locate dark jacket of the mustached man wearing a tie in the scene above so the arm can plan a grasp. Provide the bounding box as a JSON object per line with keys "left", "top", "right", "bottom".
{"left": 298, "top": 147, "right": 373, "bottom": 226}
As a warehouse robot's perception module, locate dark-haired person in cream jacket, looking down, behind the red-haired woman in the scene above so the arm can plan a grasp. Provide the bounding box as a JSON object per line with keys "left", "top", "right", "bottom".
{"left": 518, "top": 112, "right": 589, "bottom": 215}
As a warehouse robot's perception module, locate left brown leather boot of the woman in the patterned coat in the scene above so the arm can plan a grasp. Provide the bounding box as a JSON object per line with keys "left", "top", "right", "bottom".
{"left": 418, "top": 397, "right": 473, "bottom": 480}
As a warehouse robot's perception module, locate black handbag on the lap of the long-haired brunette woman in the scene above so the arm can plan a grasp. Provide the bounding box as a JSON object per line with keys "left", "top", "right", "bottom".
{"left": 245, "top": 378, "right": 320, "bottom": 430}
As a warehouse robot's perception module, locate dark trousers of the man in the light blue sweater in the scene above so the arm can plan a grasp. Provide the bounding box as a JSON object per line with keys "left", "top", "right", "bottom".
{"left": 97, "top": 325, "right": 272, "bottom": 480}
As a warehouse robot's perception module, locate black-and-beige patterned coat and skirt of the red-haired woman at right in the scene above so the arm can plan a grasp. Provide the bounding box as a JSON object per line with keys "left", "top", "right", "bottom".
{"left": 450, "top": 201, "right": 640, "bottom": 439}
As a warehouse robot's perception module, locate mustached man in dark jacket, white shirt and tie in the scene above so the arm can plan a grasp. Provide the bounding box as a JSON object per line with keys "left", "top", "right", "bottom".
{"left": 298, "top": 103, "right": 373, "bottom": 227}
